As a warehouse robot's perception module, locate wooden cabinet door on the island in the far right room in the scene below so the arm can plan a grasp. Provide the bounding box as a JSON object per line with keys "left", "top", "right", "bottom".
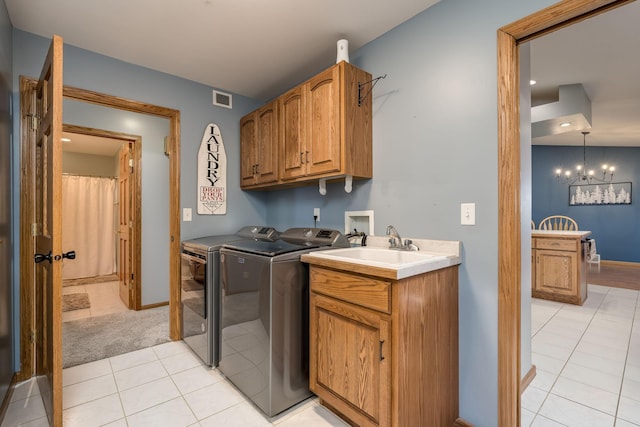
{"left": 535, "top": 249, "right": 578, "bottom": 296}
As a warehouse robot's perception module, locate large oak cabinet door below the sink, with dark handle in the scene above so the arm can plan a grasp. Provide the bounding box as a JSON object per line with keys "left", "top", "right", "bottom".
{"left": 309, "top": 293, "right": 391, "bottom": 426}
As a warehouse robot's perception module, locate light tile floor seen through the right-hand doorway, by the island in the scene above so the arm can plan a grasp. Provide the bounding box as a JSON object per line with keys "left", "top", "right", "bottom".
{"left": 521, "top": 285, "right": 640, "bottom": 427}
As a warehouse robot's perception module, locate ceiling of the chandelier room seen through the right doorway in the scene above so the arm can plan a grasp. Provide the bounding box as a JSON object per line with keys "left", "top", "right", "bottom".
{"left": 531, "top": 2, "right": 640, "bottom": 146}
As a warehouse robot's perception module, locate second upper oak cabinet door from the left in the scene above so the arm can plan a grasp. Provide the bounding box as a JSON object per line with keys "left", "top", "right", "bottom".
{"left": 256, "top": 101, "right": 278, "bottom": 184}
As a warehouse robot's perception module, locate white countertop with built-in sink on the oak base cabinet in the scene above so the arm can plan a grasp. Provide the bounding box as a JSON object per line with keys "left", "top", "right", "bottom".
{"left": 302, "top": 246, "right": 460, "bottom": 279}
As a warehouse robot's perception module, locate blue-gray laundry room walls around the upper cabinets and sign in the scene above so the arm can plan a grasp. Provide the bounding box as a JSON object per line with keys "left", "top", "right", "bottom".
{"left": 5, "top": 0, "right": 568, "bottom": 427}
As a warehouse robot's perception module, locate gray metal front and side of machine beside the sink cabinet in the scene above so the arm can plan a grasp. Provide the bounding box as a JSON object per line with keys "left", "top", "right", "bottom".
{"left": 220, "top": 248, "right": 311, "bottom": 417}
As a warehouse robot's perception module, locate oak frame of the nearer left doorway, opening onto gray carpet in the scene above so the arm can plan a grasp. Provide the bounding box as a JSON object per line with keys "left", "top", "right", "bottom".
{"left": 17, "top": 76, "right": 182, "bottom": 381}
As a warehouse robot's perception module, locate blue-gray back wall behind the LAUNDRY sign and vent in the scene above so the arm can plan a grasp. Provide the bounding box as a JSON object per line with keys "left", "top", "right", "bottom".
{"left": 13, "top": 29, "right": 266, "bottom": 239}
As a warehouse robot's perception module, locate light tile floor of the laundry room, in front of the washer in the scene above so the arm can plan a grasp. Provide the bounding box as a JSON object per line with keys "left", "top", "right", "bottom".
{"left": 2, "top": 341, "right": 347, "bottom": 427}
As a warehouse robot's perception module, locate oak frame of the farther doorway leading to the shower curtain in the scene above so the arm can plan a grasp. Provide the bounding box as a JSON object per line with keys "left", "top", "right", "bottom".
{"left": 62, "top": 124, "right": 143, "bottom": 310}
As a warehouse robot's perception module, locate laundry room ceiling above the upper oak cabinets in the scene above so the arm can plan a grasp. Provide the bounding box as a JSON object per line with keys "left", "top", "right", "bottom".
{"left": 5, "top": 0, "right": 438, "bottom": 101}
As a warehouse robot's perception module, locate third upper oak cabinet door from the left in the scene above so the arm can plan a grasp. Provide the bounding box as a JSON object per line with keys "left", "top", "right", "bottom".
{"left": 279, "top": 86, "right": 309, "bottom": 180}
